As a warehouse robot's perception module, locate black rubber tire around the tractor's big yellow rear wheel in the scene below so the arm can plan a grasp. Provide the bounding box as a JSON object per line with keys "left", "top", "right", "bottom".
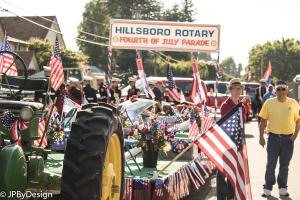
{"left": 61, "top": 105, "right": 124, "bottom": 200}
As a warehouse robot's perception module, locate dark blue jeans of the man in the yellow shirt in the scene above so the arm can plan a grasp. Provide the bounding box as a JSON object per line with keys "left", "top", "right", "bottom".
{"left": 264, "top": 134, "right": 294, "bottom": 190}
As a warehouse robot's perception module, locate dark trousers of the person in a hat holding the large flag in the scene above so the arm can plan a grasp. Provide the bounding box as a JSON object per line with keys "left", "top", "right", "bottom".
{"left": 217, "top": 171, "right": 234, "bottom": 200}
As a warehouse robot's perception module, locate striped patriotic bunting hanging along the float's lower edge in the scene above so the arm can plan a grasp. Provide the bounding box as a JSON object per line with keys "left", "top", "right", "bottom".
{"left": 125, "top": 155, "right": 216, "bottom": 200}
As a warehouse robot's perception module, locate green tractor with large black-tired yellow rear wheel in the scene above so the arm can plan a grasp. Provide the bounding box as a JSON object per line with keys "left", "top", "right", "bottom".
{"left": 0, "top": 51, "right": 124, "bottom": 200}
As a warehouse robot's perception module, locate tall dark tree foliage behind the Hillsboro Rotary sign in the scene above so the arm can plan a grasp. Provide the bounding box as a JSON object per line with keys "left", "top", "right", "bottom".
{"left": 77, "top": 0, "right": 194, "bottom": 75}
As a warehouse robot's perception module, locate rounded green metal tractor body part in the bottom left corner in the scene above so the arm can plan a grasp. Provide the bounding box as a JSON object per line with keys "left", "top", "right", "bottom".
{"left": 0, "top": 144, "right": 27, "bottom": 192}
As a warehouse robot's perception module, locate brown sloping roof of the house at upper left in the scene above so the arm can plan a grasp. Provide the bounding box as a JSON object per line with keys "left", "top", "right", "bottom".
{"left": 0, "top": 16, "right": 57, "bottom": 41}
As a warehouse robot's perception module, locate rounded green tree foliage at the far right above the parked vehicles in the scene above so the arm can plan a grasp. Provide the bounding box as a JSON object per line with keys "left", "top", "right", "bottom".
{"left": 249, "top": 38, "right": 300, "bottom": 80}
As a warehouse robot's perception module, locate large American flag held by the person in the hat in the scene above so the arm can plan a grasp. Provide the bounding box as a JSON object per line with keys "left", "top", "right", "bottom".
{"left": 195, "top": 103, "right": 252, "bottom": 200}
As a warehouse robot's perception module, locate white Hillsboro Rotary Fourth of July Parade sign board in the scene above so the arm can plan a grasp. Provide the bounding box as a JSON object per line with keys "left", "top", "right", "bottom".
{"left": 110, "top": 19, "right": 220, "bottom": 52}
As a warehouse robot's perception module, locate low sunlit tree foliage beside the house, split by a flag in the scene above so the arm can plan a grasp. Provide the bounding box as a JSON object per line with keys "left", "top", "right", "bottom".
{"left": 28, "top": 38, "right": 87, "bottom": 68}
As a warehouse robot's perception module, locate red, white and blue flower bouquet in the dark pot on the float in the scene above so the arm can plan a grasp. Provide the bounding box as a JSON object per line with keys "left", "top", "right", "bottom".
{"left": 128, "top": 115, "right": 170, "bottom": 151}
